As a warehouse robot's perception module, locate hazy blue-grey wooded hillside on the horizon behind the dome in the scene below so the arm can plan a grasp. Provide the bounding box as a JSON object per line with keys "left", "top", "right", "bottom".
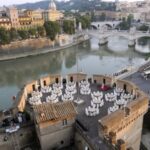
{"left": 17, "top": 0, "right": 115, "bottom": 11}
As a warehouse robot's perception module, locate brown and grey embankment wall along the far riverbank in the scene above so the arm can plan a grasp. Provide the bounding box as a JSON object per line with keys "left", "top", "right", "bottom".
{"left": 0, "top": 34, "right": 89, "bottom": 61}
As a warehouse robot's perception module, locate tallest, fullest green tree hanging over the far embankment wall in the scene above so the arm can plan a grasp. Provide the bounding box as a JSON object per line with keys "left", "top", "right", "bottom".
{"left": 44, "top": 21, "right": 60, "bottom": 41}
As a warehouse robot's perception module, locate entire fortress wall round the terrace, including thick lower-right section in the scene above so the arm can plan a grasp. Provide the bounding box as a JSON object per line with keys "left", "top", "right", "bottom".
{"left": 14, "top": 73, "right": 148, "bottom": 150}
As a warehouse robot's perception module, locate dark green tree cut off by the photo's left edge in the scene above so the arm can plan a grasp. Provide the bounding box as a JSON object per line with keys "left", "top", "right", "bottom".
{"left": 0, "top": 27, "right": 11, "bottom": 44}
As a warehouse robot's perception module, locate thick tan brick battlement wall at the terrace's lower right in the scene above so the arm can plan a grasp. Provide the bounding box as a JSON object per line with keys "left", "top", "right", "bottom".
{"left": 99, "top": 89, "right": 148, "bottom": 150}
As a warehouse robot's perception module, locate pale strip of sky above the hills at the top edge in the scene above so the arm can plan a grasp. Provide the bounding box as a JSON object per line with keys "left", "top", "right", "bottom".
{"left": 0, "top": 0, "right": 145, "bottom": 6}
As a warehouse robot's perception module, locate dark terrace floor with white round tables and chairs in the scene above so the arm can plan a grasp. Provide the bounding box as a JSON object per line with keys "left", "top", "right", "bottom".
{"left": 28, "top": 75, "right": 135, "bottom": 150}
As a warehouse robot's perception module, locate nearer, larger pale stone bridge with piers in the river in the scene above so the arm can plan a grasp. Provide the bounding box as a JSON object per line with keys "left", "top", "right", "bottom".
{"left": 86, "top": 30, "right": 150, "bottom": 46}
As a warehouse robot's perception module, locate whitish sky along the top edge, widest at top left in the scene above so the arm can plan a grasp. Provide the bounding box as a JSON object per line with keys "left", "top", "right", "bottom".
{"left": 0, "top": 0, "right": 143, "bottom": 6}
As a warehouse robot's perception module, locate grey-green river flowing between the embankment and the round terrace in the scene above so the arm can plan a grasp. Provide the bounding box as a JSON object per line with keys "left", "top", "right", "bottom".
{"left": 0, "top": 37, "right": 150, "bottom": 110}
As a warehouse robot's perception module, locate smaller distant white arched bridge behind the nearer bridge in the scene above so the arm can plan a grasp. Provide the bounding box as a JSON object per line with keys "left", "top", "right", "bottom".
{"left": 91, "top": 21, "right": 121, "bottom": 29}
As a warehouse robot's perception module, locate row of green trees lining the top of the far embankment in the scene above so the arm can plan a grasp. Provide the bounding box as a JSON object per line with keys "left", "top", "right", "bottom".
{"left": 0, "top": 15, "right": 91, "bottom": 44}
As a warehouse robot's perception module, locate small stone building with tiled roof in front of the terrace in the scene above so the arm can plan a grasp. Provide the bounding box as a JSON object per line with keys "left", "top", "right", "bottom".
{"left": 33, "top": 102, "right": 77, "bottom": 150}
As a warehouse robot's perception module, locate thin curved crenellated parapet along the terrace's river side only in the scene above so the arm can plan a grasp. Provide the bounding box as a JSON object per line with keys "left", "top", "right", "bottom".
{"left": 14, "top": 73, "right": 145, "bottom": 111}
